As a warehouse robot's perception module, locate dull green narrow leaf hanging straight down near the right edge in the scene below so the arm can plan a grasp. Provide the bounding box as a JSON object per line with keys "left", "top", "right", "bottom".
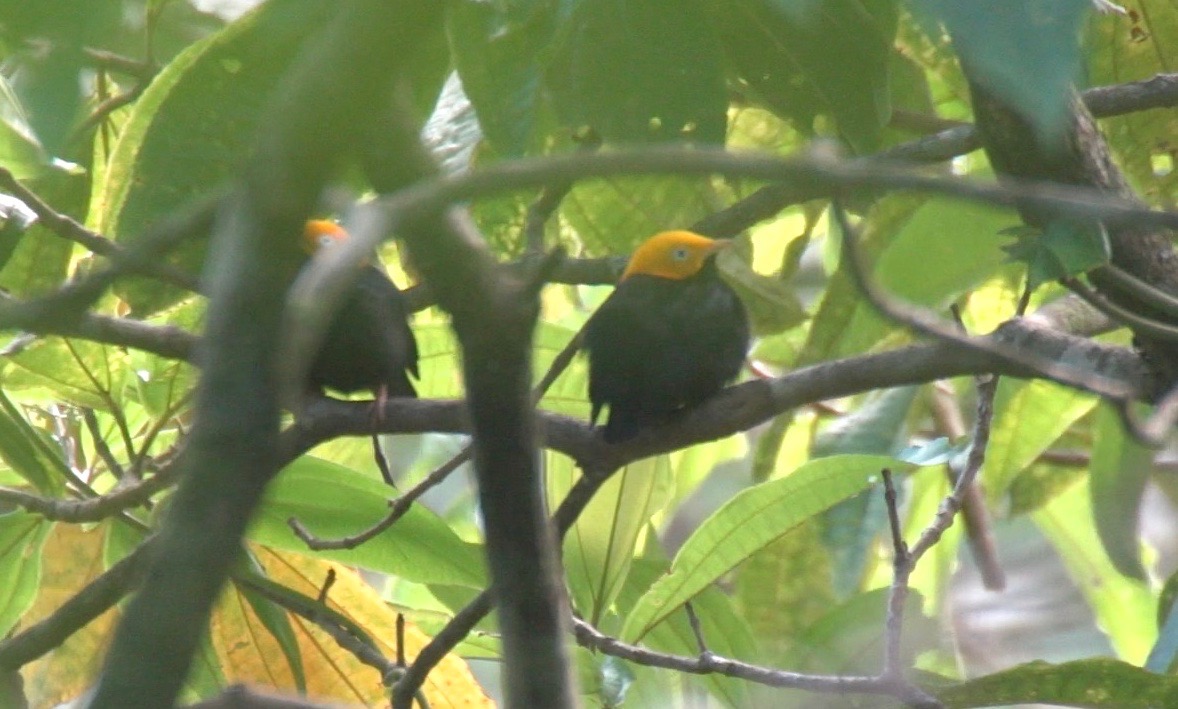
{"left": 1088, "top": 406, "right": 1153, "bottom": 581}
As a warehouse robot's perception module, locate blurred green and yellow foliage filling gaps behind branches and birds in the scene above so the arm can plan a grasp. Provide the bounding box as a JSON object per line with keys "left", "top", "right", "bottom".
{"left": 0, "top": 0, "right": 1178, "bottom": 707}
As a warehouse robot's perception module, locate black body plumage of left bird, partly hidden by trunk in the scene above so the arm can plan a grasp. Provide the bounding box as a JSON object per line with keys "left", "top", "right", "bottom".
{"left": 310, "top": 266, "right": 418, "bottom": 397}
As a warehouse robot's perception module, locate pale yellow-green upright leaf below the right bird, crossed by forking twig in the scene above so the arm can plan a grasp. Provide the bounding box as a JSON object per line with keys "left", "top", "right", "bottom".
{"left": 545, "top": 451, "right": 673, "bottom": 624}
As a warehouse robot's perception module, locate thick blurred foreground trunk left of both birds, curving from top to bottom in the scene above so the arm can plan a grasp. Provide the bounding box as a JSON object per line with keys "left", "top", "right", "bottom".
{"left": 85, "top": 0, "right": 439, "bottom": 709}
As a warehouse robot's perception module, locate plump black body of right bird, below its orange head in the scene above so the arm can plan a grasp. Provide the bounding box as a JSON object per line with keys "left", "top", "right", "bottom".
{"left": 585, "top": 257, "right": 749, "bottom": 443}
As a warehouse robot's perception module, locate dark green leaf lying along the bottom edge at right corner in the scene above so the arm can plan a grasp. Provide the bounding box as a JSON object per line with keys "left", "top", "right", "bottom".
{"left": 927, "top": 658, "right": 1178, "bottom": 709}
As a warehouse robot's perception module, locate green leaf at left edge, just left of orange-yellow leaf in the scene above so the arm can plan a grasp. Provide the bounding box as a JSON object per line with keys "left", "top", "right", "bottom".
{"left": 0, "top": 512, "right": 53, "bottom": 637}
